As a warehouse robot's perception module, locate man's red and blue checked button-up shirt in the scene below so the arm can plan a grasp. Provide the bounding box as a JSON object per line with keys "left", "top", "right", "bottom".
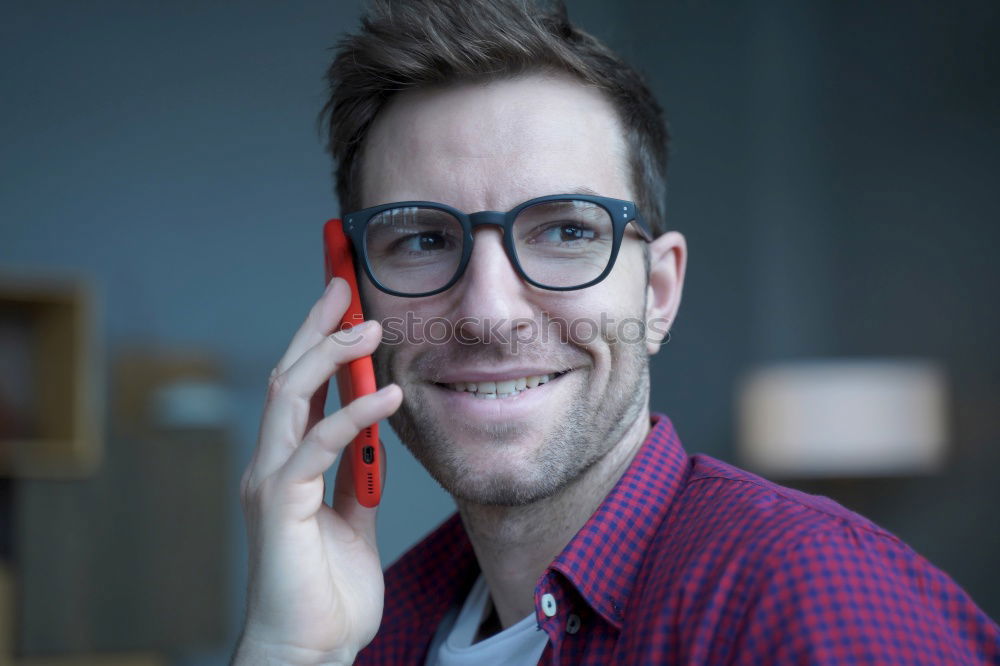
{"left": 357, "top": 416, "right": 1000, "bottom": 666}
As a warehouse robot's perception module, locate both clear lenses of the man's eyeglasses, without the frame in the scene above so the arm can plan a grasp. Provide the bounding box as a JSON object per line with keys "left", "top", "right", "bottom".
{"left": 365, "top": 200, "right": 614, "bottom": 294}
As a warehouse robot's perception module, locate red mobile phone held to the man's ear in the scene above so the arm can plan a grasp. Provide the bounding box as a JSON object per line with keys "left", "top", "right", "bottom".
{"left": 323, "top": 220, "right": 383, "bottom": 507}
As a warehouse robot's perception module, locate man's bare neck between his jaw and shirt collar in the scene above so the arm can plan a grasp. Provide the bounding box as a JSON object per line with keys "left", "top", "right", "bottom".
{"left": 458, "top": 409, "right": 649, "bottom": 638}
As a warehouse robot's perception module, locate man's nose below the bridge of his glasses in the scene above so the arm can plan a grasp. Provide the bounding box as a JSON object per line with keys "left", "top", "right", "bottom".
{"left": 453, "top": 227, "right": 532, "bottom": 342}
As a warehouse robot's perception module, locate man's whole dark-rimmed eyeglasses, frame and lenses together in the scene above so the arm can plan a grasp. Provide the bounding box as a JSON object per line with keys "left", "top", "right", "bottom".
{"left": 343, "top": 194, "right": 653, "bottom": 298}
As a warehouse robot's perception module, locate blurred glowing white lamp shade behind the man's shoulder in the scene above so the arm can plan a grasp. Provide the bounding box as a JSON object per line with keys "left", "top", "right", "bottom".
{"left": 737, "top": 359, "right": 947, "bottom": 478}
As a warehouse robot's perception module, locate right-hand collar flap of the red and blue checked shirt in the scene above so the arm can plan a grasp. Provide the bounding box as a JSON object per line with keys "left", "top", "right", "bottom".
{"left": 549, "top": 414, "right": 688, "bottom": 630}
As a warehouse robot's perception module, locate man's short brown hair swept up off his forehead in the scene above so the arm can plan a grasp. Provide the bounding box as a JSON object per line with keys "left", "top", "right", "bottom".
{"left": 320, "top": 0, "right": 669, "bottom": 235}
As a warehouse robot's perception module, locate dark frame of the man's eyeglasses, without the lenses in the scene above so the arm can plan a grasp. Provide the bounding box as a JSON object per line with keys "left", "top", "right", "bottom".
{"left": 342, "top": 194, "right": 653, "bottom": 298}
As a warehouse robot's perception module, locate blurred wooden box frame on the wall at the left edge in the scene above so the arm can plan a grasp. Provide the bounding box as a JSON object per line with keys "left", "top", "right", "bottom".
{"left": 0, "top": 274, "right": 104, "bottom": 478}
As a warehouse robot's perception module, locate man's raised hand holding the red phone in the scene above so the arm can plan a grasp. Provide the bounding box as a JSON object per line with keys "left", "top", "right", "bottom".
{"left": 234, "top": 279, "right": 403, "bottom": 664}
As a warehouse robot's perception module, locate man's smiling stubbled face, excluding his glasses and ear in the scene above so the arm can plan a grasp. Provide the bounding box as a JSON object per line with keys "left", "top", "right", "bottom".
{"left": 362, "top": 75, "right": 648, "bottom": 505}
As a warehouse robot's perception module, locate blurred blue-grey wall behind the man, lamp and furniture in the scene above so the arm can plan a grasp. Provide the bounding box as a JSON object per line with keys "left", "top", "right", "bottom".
{"left": 0, "top": 0, "right": 1000, "bottom": 664}
